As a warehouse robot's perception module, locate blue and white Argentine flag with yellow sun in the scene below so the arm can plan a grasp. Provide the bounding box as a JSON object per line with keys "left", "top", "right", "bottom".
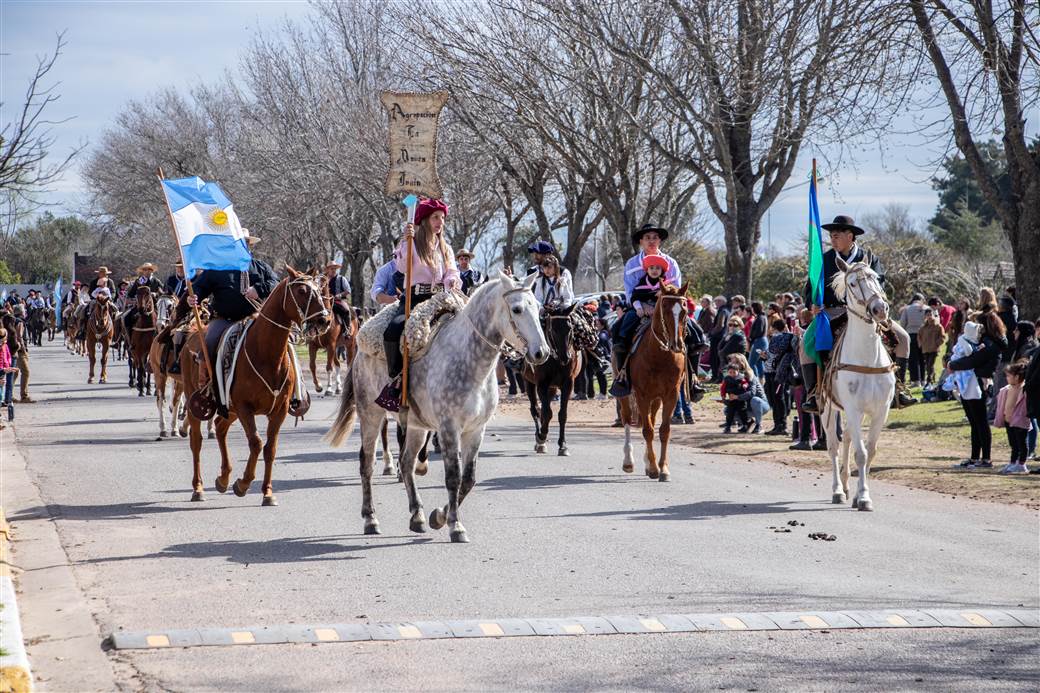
{"left": 162, "top": 176, "right": 252, "bottom": 277}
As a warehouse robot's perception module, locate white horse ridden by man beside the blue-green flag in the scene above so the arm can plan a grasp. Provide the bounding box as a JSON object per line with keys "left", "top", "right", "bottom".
{"left": 823, "top": 257, "right": 895, "bottom": 511}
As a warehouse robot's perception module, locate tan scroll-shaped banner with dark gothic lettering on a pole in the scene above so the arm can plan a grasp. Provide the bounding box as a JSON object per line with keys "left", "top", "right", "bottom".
{"left": 380, "top": 92, "right": 448, "bottom": 198}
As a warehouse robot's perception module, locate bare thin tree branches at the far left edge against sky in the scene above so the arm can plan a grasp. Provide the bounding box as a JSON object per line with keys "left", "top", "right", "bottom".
{"left": 0, "top": 32, "right": 82, "bottom": 210}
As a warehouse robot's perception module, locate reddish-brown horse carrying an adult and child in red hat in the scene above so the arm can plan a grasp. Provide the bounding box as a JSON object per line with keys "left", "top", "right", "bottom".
{"left": 621, "top": 284, "right": 686, "bottom": 482}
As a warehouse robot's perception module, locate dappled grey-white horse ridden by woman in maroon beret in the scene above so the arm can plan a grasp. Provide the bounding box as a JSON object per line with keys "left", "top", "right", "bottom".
{"left": 327, "top": 273, "right": 549, "bottom": 542}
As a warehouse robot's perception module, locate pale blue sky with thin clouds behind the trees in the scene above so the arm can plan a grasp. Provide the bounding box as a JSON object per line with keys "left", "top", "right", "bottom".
{"left": 0, "top": 0, "right": 1023, "bottom": 252}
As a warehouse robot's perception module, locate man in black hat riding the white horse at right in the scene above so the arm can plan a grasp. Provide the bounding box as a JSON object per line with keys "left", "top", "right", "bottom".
{"left": 799, "top": 214, "right": 917, "bottom": 414}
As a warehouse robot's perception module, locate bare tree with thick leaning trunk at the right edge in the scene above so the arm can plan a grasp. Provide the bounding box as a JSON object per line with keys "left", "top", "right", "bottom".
{"left": 908, "top": 0, "right": 1040, "bottom": 318}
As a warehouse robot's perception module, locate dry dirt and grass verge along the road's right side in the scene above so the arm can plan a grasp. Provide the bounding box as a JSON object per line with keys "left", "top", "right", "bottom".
{"left": 499, "top": 393, "right": 1040, "bottom": 510}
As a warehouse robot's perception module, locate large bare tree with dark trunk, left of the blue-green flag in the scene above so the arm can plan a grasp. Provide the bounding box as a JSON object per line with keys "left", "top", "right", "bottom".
{"left": 572, "top": 0, "right": 904, "bottom": 294}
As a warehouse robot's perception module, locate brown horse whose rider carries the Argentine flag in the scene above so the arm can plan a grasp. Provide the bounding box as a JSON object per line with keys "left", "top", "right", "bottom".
{"left": 181, "top": 265, "right": 329, "bottom": 506}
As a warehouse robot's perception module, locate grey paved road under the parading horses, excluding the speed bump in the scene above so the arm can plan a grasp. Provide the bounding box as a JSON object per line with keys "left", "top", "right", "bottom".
{"left": 8, "top": 342, "right": 1040, "bottom": 690}
